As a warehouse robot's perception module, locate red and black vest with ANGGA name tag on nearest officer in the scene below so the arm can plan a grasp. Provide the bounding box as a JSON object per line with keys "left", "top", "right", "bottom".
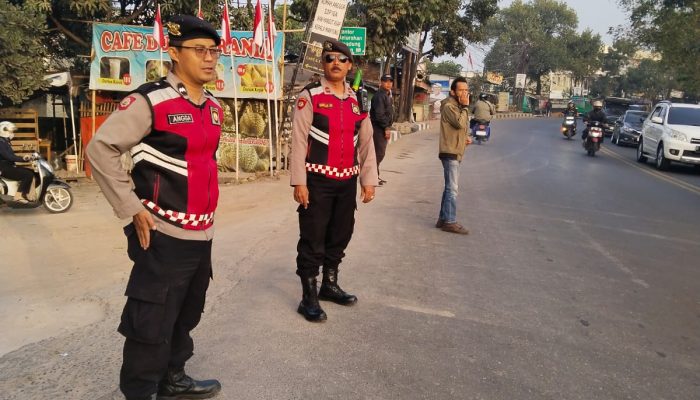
{"left": 125, "top": 80, "right": 224, "bottom": 230}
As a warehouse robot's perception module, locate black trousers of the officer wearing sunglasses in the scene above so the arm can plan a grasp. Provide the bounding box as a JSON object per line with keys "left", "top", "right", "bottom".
{"left": 297, "top": 173, "right": 357, "bottom": 278}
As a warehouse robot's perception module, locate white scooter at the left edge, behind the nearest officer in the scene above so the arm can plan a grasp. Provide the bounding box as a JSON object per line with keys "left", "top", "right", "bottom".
{"left": 0, "top": 153, "right": 73, "bottom": 213}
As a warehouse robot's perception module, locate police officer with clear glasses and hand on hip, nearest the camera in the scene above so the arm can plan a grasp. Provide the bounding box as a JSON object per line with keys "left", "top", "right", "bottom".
{"left": 87, "top": 15, "right": 223, "bottom": 399}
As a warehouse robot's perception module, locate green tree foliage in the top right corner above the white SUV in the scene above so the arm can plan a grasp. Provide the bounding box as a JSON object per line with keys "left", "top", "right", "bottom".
{"left": 619, "top": 0, "right": 700, "bottom": 96}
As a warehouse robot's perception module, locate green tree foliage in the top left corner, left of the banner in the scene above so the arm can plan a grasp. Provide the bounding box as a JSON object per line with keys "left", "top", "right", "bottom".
{"left": 0, "top": 0, "right": 46, "bottom": 106}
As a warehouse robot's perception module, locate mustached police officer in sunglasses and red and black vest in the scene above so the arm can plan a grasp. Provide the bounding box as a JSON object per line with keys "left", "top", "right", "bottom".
{"left": 290, "top": 40, "right": 378, "bottom": 322}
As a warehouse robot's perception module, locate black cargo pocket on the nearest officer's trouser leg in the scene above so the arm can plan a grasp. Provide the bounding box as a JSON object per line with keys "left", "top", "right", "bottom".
{"left": 119, "top": 282, "right": 170, "bottom": 344}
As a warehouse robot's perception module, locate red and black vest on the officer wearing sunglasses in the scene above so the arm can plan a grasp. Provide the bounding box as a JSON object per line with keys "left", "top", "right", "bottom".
{"left": 305, "top": 82, "right": 367, "bottom": 180}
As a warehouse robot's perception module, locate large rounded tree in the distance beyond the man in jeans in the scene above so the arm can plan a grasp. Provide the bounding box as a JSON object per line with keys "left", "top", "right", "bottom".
{"left": 485, "top": 0, "right": 578, "bottom": 94}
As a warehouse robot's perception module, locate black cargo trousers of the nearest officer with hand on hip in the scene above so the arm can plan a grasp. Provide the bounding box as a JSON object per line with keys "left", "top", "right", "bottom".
{"left": 119, "top": 224, "right": 212, "bottom": 399}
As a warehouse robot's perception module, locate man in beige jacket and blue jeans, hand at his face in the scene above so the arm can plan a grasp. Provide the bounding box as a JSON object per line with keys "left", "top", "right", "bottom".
{"left": 435, "top": 77, "right": 472, "bottom": 235}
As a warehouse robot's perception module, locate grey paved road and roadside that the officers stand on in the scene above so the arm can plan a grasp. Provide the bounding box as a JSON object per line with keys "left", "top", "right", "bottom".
{"left": 0, "top": 119, "right": 700, "bottom": 400}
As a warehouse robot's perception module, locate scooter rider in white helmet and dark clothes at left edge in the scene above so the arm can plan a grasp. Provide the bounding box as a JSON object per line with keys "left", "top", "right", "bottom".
{"left": 0, "top": 121, "right": 34, "bottom": 204}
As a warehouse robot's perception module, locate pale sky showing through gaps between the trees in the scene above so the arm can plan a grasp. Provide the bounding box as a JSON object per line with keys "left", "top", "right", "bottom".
{"left": 436, "top": 0, "right": 628, "bottom": 71}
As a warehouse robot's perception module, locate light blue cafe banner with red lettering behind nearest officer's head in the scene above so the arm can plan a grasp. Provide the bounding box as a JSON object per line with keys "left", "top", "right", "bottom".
{"left": 90, "top": 24, "right": 283, "bottom": 99}
